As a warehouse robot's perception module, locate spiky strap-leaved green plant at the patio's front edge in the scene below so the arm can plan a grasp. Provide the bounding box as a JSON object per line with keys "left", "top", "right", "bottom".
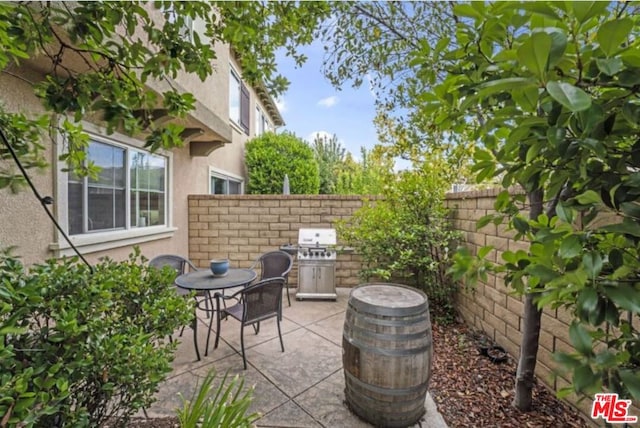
{"left": 177, "top": 370, "right": 260, "bottom": 428}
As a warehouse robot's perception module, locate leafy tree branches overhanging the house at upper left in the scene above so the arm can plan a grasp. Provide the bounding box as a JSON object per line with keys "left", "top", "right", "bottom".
{"left": 0, "top": 1, "right": 329, "bottom": 190}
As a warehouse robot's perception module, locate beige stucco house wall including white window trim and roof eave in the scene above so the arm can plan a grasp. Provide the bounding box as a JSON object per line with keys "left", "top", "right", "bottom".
{"left": 0, "top": 6, "right": 283, "bottom": 264}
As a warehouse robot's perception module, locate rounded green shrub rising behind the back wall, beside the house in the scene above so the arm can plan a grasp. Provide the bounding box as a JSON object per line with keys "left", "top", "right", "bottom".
{"left": 245, "top": 132, "right": 320, "bottom": 195}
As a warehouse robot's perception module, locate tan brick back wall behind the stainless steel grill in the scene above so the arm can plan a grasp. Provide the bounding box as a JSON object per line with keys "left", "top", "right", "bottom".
{"left": 189, "top": 195, "right": 362, "bottom": 287}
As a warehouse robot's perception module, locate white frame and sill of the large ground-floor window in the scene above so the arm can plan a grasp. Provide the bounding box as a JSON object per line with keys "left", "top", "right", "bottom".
{"left": 49, "top": 122, "right": 178, "bottom": 257}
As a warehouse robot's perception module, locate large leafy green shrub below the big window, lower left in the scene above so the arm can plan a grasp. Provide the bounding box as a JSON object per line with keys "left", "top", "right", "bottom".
{"left": 0, "top": 250, "right": 193, "bottom": 427}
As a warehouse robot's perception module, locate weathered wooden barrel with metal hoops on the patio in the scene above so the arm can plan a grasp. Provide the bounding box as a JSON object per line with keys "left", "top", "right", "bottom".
{"left": 342, "top": 283, "right": 433, "bottom": 427}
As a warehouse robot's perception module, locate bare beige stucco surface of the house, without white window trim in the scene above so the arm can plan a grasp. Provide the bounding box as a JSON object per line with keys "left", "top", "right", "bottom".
{"left": 0, "top": 11, "right": 280, "bottom": 264}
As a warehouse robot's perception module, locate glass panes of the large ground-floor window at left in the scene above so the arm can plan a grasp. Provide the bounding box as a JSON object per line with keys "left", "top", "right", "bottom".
{"left": 68, "top": 141, "right": 167, "bottom": 235}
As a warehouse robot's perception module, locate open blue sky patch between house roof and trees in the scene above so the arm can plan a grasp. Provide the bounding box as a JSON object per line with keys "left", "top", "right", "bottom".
{"left": 278, "top": 42, "right": 378, "bottom": 159}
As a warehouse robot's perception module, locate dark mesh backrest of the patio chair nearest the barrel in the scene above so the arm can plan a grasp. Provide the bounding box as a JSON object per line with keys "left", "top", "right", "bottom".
{"left": 242, "top": 277, "right": 284, "bottom": 322}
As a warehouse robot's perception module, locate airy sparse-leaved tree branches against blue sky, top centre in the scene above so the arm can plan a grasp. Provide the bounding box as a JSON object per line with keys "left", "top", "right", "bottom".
{"left": 321, "top": 2, "right": 457, "bottom": 161}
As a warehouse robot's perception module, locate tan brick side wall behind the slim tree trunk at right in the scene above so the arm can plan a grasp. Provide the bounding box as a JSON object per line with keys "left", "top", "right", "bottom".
{"left": 446, "top": 189, "right": 604, "bottom": 419}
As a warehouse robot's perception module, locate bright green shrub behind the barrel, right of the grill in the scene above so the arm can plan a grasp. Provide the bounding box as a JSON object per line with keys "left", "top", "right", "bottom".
{"left": 338, "top": 166, "right": 459, "bottom": 322}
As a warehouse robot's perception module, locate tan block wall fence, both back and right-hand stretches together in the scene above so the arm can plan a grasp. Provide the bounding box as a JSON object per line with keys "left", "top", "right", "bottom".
{"left": 189, "top": 189, "right": 608, "bottom": 415}
